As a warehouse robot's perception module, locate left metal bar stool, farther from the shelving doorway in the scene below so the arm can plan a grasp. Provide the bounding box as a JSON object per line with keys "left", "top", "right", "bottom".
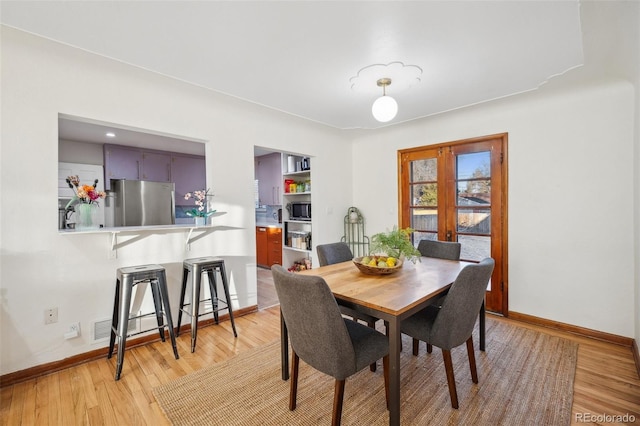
{"left": 107, "top": 265, "right": 179, "bottom": 380}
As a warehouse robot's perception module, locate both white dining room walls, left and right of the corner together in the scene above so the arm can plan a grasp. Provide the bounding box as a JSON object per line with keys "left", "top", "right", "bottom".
{"left": 0, "top": 23, "right": 640, "bottom": 374}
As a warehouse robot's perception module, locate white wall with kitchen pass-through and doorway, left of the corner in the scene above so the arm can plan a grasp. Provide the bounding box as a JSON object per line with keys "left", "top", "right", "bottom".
{"left": 0, "top": 27, "right": 351, "bottom": 374}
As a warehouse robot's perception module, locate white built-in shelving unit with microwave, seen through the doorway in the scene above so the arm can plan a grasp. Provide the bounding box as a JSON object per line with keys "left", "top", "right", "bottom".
{"left": 282, "top": 154, "right": 313, "bottom": 268}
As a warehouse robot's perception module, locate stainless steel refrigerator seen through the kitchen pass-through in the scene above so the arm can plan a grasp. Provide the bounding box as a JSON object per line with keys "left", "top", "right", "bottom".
{"left": 111, "top": 179, "right": 176, "bottom": 226}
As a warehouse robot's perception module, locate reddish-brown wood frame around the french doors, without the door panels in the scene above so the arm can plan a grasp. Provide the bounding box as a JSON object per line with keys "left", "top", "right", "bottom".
{"left": 397, "top": 132, "right": 509, "bottom": 317}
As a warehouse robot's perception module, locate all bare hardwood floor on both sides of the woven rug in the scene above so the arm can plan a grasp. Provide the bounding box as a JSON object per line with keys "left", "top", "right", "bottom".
{"left": 0, "top": 288, "right": 640, "bottom": 426}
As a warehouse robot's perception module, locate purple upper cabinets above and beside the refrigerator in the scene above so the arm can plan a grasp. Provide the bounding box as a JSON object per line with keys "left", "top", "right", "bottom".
{"left": 104, "top": 144, "right": 206, "bottom": 195}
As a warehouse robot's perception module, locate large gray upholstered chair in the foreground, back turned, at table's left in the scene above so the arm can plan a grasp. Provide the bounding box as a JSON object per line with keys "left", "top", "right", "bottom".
{"left": 271, "top": 265, "right": 389, "bottom": 425}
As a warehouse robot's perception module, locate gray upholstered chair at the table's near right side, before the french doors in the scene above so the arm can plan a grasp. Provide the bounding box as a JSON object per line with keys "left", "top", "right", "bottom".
{"left": 400, "top": 257, "right": 495, "bottom": 408}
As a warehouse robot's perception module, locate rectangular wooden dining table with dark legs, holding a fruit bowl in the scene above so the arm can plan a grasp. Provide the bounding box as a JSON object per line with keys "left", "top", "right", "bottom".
{"left": 280, "top": 257, "right": 484, "bottom": 425}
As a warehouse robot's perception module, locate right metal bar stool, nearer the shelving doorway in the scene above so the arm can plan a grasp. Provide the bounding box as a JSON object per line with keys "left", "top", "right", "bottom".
{"left": 176, "top": 256, "right": 238, "bottom": 352}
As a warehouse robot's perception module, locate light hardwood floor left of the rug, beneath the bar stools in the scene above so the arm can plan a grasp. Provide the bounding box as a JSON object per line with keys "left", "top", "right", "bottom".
{"left": 0, "top": 307, "right": 280, "bottom": 426}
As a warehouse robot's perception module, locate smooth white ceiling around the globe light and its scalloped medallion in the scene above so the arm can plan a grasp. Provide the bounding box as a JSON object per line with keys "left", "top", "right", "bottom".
{"left": 0, "top": 0, "right": 596, "bottom": 129}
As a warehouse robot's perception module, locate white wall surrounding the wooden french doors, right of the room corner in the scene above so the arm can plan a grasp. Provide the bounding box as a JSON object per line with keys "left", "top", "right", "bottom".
{"left": 353, "top": 82, "right": 638, "bottom": 337}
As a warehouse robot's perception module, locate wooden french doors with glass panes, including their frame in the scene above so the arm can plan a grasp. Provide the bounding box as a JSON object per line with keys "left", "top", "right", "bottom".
{"left": 398, "top": 133, "right": 508, "bottom": 314}
